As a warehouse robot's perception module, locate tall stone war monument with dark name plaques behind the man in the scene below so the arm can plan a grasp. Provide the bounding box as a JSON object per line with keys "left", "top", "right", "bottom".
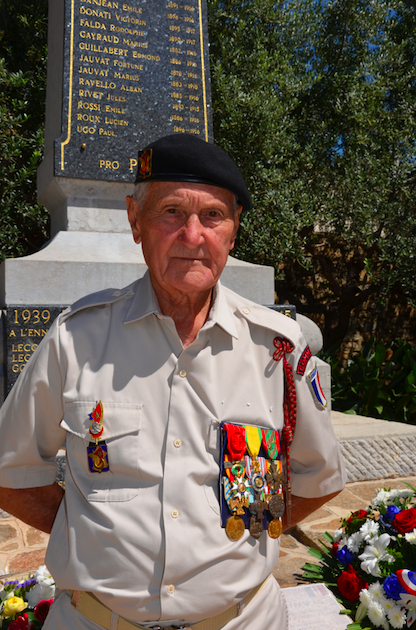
{"left": 0, "top": 0, "right": 274, "bottom": 402}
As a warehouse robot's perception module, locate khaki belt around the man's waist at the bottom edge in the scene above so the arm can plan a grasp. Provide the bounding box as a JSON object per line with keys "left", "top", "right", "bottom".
{"left": 69, "top": 577, "right": 269, "bottom": 630}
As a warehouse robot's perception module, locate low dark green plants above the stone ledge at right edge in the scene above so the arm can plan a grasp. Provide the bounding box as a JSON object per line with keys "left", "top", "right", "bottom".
{"left": 323, "top": 339, "right": 416, "bottom": 424}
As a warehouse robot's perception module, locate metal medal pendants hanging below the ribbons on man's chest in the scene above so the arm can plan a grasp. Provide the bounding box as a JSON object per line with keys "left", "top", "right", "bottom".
{"left": 223, "top": 457, "right": 285, "bottom": 540}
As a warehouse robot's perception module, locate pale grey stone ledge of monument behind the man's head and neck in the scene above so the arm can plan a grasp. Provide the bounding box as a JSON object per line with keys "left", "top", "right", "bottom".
{"left": 0, "top": 232, "right": 274, "bottom": 308}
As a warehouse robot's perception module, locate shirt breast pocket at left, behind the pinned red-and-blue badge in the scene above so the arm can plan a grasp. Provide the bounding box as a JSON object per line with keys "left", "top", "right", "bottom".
{"left": 61, "top": 401, "right": 143, "bottom": 502}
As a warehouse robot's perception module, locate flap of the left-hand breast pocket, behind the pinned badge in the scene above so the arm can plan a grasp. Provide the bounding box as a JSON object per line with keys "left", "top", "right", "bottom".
{"left": 61, "top": 401, "right": 143, "bottom": 442}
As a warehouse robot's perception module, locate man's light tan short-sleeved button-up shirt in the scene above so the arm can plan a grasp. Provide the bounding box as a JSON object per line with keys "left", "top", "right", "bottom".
{"left": 0, "top": 274, "right": 345, "bottom": 622}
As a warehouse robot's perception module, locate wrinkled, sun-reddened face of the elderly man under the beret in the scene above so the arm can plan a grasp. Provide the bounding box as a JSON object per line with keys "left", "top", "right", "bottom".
{"left": 127, "top": 182, "right": 241, "bottom": 302}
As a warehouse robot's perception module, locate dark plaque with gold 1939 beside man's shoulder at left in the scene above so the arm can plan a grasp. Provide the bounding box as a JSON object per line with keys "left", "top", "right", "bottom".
{"left": 6, "top": 305, "right": 66, "bottom": 393}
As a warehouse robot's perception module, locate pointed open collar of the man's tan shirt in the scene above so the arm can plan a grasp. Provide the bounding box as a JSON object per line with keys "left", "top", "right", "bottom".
{"left": 124, "top": 271, "right": 238, "bottom": 339}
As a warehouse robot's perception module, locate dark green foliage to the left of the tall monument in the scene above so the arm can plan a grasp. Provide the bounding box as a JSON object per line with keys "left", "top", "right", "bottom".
{"left": 0, "top": 0, "right": 49, "bottom": 261}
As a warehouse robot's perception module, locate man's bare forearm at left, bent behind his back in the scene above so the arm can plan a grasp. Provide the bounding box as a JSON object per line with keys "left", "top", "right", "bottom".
{"left": 0, "top": 483, "right": 64, "bottom": 534}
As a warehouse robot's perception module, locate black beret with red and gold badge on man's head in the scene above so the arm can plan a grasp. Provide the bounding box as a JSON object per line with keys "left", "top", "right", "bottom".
{"left": 135, "top": 133, "right": 252, "bottom": 210}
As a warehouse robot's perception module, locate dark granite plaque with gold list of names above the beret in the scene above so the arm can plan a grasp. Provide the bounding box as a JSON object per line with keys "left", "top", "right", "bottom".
{"left": 54, "top": 0, "right": 212, "bottom": 182}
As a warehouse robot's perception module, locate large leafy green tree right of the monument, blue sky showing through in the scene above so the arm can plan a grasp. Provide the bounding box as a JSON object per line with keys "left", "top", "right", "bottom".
{"left": 208, "top": 0, "right": 416, "bottom": 347}
